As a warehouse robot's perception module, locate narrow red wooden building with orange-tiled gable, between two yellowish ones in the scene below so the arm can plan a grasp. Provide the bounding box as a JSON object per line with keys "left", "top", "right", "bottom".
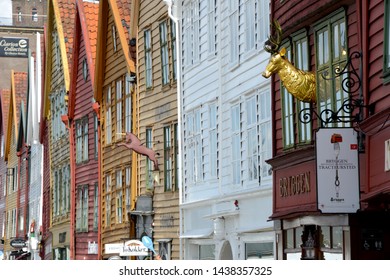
{"left": 68, "top": 0, "right": 100, "bottom": 259}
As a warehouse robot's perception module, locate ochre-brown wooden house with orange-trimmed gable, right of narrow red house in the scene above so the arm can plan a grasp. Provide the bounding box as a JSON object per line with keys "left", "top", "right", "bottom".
{"left": 94, "top": 0, "right": 136, "bottom": 259}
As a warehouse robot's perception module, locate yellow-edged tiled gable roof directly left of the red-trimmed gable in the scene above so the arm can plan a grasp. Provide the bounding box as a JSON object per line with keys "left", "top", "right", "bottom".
{"left": 42, "top": 0, "right": 76, "bottom": 116}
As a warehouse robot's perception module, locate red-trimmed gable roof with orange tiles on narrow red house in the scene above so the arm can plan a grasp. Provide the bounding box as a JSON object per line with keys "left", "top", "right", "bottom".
{"left": 68, "top": 0, "right": 99, "bottom": 118}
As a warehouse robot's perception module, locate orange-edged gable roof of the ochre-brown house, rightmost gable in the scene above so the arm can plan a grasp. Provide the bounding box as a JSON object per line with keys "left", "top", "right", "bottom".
{"left": 94, "top": 0, "right": 135, "bottom": 103}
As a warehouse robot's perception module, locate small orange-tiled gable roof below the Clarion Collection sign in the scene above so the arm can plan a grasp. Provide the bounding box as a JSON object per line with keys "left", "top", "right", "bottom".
{"left": 4, "top": 70, "right": 27, "bottom": 160}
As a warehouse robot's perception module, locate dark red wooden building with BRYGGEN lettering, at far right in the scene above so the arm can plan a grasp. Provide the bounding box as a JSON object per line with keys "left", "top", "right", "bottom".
{"left": 269, "top": 0, "right": 390, "bottom": 259}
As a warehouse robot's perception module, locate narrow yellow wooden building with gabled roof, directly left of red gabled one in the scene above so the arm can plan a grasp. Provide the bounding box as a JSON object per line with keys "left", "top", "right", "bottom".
{"left": 42, "top": 0, "right": 76, "bottom": 260}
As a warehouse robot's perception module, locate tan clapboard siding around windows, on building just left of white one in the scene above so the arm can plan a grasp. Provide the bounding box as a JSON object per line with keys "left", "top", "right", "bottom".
{"left": 137, "top": 0, "right": 180, "bottom": 259}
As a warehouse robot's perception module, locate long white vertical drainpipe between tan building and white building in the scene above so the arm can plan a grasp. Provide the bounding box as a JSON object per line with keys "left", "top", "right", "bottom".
{"left": 163, "top": 0, "right": 183, "bottom": 260}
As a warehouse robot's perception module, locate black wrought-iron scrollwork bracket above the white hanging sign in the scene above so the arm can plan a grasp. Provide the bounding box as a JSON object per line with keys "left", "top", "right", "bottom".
{"left": 299, "top": 52, "right": 366, "bottom": 126}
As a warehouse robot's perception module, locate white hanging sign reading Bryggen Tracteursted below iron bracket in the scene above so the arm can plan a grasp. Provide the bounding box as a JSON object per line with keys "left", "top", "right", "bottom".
{"left": 316, "top": 128, "right": 360, "bottom": 213}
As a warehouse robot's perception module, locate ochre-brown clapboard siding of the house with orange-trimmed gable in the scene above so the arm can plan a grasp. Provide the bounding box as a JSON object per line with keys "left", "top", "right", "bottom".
{"left": 96, "top": 0, "right": 134, "bottom": 258}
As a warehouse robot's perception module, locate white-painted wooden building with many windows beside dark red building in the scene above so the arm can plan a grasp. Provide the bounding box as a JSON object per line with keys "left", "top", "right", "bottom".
{"left": 175, "top": 0, "right": 275, "bottom": 260}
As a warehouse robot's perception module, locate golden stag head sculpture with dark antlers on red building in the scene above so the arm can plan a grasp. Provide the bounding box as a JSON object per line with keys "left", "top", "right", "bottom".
{"left": 262, "top": 20, "right": 316, "bottom": 103}
